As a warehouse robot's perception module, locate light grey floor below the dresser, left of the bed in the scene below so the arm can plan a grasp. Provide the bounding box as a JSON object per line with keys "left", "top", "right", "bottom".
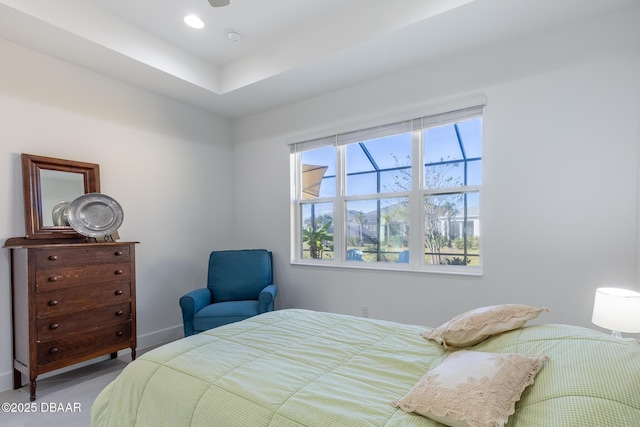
{"left": 0, "top": 355, "right": 131, "bottom": 427}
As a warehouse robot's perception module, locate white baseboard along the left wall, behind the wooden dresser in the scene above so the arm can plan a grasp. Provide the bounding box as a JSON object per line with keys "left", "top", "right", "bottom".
{"left": 0, "top": 324, "right": 184, "bottom": 392}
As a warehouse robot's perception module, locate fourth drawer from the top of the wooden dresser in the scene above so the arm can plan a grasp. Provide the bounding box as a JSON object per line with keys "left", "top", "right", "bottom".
{"left": 38, "top": 302, "right": 132, "bottom": 341}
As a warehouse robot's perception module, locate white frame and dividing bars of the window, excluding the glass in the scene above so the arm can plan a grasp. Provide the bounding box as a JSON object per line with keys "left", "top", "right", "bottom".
{"left": 289, "top": 102, "right": 485, "bottom": 275}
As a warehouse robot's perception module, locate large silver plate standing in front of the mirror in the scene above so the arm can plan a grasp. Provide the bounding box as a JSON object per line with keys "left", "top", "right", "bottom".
{"left": 67, "top": 193, "right": 124, "bottom": 237}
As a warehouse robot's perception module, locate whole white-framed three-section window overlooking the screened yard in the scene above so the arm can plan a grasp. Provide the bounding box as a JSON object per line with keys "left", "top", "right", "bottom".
{"left": 291, "top": 106, "right": 482, "bottom": 273}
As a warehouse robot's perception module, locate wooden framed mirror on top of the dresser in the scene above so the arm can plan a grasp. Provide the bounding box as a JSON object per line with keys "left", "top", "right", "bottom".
{"left": 22, "top": 154, "right": 100, "bottom": 239}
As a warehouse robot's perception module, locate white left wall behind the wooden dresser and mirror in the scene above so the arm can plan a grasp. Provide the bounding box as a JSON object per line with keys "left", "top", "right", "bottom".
{"left": 0, "top": 41, "right": 233, "bottom": 390}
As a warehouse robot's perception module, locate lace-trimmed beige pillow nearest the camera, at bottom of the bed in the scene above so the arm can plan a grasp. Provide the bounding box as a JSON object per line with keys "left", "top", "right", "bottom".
{"left": 392, "top": 350, "right": 548, "bottom": 427}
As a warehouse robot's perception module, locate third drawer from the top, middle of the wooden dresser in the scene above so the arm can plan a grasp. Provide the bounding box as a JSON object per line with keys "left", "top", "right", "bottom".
{"left": 36, "top": 282, "right": 131, "bottom": 318}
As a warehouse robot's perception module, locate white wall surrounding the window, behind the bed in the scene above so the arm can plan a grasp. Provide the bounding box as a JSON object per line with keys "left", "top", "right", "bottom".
{"left": 234, "top": 5, "right": 640, "bottom": 326}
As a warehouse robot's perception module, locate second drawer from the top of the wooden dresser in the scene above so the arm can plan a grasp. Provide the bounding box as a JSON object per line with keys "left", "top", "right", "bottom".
{"left": 36, "top": 263, "right": 131, "bottom": 290}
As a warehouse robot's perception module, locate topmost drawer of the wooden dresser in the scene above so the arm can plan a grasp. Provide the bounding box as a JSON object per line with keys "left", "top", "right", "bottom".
{"left": 34, "top": 244, "right": 131, "bottom": 268}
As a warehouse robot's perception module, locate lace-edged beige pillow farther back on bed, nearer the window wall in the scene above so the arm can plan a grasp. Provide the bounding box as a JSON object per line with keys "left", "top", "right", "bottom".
{"left": 422, "top": 304, "right": 549, "bottom": 348}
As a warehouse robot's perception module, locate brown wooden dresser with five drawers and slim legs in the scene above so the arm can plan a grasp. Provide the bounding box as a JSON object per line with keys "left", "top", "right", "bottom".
{"left": 5, "top": 242, "right": 136, "bottom": 401}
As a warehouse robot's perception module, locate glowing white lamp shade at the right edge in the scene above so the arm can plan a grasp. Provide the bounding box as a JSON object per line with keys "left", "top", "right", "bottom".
{"left": 591, "top": 288, "right": 640, "bottom": 333}
